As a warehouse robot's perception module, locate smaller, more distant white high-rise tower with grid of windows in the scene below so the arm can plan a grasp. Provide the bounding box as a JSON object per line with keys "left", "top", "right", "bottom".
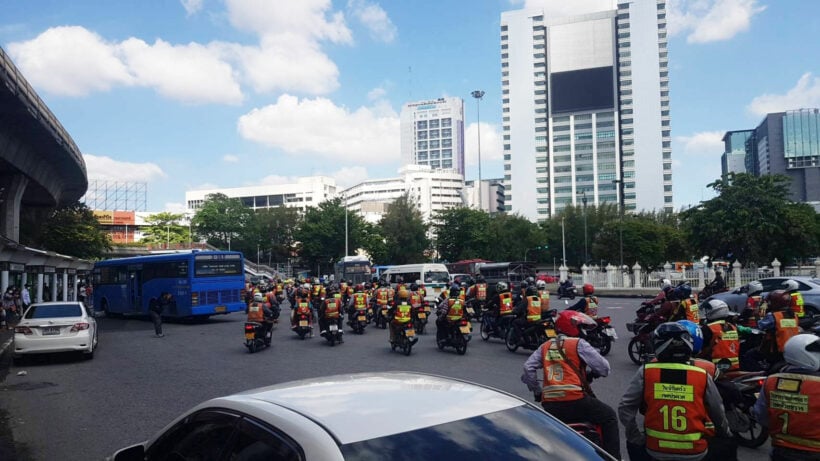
{"left": 401, "top": 98, "right": 464, "bottom": 176}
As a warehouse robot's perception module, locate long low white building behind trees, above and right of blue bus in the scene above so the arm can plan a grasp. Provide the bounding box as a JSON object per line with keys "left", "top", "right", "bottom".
{"left": 185, "top": 176, "right": 337, "bottom": 212}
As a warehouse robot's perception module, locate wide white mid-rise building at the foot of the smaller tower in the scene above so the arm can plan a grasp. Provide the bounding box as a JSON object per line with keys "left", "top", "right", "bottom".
{"left": 341, "top": 165, "right": 464, "bottom": 223}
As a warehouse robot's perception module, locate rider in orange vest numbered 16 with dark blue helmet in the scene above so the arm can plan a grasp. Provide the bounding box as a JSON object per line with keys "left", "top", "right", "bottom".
{"left": 618, "top": 322, "right": 732, "bottom": 461}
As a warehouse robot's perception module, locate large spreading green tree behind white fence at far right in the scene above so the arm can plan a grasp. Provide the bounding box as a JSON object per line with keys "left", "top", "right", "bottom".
{"left": 681, "top": 173, "right": 818, "bottom": 265}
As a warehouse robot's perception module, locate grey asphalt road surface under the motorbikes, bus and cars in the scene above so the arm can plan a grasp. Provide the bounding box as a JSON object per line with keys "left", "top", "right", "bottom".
{"left": 0, "top": 297, "right": 768, "bottom": 461}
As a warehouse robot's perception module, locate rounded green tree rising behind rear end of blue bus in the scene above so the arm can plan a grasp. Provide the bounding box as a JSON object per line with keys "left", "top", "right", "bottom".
{"left": 191, "top": 194, "right": 256, "bottom": 251}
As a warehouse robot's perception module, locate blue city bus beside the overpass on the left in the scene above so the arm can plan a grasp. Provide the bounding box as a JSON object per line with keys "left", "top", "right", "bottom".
{"left": 92, "top": 250, "right": 245, "bottom": 318}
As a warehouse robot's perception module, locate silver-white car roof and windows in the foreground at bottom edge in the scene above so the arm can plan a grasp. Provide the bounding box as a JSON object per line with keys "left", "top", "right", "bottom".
{"left": 112, "top": 372, "right": 612, "bottom": 461}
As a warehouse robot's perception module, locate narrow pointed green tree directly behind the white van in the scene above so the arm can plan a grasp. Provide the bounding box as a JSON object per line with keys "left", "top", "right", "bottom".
{"left": 379, "top": 194, "right": 430, "bottom": 264}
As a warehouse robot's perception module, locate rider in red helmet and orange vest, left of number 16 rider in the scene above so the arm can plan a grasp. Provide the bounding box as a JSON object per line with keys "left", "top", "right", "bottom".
{"left": 521, "top": 310, "right": 621, "bottom": 459}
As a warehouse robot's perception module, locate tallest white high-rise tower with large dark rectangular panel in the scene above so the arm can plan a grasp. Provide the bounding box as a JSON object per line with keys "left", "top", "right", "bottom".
{"left": 501, "top": 0, "right": 673, "bottom": 221}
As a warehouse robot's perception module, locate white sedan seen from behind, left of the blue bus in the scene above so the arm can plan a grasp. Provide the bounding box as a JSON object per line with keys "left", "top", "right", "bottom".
{"left": 12, "top": 302, "right": 97, "bottom": 365}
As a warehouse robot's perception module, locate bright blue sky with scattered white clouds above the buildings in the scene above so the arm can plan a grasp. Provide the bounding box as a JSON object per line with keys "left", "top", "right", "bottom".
{"left": 0, "top": 0, "right": 820, "bottom": 211}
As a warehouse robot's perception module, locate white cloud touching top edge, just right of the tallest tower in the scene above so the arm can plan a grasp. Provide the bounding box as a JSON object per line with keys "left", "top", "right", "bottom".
{"left": 667, "top": 0, "right": 766, "bottom": 43}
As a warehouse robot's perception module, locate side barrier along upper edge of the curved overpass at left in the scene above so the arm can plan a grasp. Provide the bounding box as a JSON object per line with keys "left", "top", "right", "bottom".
{"left": 0, "top": 47, "right": 86, "bottom": 174}
